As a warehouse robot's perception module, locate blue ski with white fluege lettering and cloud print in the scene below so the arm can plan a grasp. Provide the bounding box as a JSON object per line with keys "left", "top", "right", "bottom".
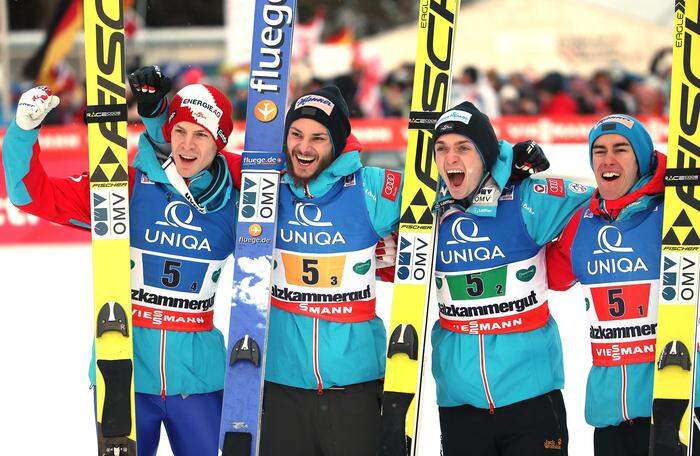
{"left": 219, "top": 0, "right": 296, "bottom": 456}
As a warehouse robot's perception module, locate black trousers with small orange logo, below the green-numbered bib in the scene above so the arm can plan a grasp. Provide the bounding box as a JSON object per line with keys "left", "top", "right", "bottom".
{"left": 440, "top": 390, "right": 569, "bottom": 456}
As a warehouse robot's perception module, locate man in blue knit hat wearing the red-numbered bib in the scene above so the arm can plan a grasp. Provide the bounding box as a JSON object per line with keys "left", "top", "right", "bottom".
{"left": 547, "top": 114, "right": 700, "bottom": 456}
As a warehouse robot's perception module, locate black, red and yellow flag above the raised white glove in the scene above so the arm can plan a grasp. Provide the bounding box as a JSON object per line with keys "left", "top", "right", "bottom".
{"left": 22, "top": 0, "right": 83, "bottom": 92}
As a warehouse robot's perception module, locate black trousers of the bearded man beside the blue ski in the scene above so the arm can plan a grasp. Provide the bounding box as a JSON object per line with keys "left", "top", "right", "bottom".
{"left": 260, "top": 380, "right": 382, "bottom": 456}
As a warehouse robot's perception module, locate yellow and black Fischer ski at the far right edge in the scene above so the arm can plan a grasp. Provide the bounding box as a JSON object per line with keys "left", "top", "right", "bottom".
{"left": 649, "top": 0, "right": 700, "bottom": 456}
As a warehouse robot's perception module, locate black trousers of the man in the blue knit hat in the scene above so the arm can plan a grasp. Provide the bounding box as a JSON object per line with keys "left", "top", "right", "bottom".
{"left": 593, "top": 407, "right": 700, "bottom": 456}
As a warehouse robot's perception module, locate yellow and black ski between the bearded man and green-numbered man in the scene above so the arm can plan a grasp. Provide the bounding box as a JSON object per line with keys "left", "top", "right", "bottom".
{"left": 380, "top": 0, "right": 460, "bottom": 456}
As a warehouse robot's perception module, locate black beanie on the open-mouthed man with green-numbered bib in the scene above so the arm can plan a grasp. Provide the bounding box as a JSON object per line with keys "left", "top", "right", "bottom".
{"left": 433, "top": 101, "right": 499, "bottom": 172}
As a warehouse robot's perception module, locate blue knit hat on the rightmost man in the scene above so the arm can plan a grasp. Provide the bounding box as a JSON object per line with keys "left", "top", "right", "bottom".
{"left": 588, "top": 114, "right": 655, "bottom": 176}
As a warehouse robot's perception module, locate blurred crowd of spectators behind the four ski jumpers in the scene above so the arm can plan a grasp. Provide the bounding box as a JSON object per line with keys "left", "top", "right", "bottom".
{"left": 8, "top": 49, "right": 671, "bottom": 124}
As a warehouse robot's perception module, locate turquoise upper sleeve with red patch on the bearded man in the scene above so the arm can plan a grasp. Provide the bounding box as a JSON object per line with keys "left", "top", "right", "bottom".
{"left": 361, "top": 167, "right": 403, "bottom": 237}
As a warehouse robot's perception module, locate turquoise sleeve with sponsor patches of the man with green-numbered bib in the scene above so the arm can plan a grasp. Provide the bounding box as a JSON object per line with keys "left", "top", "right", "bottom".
{"left": 517, "top": 178, "right": 594, "bottom": 245}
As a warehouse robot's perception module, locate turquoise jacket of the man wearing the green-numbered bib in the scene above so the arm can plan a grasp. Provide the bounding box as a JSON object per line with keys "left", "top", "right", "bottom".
{"left": 432, "top": 141, "right": 592, "bottom": 409}
